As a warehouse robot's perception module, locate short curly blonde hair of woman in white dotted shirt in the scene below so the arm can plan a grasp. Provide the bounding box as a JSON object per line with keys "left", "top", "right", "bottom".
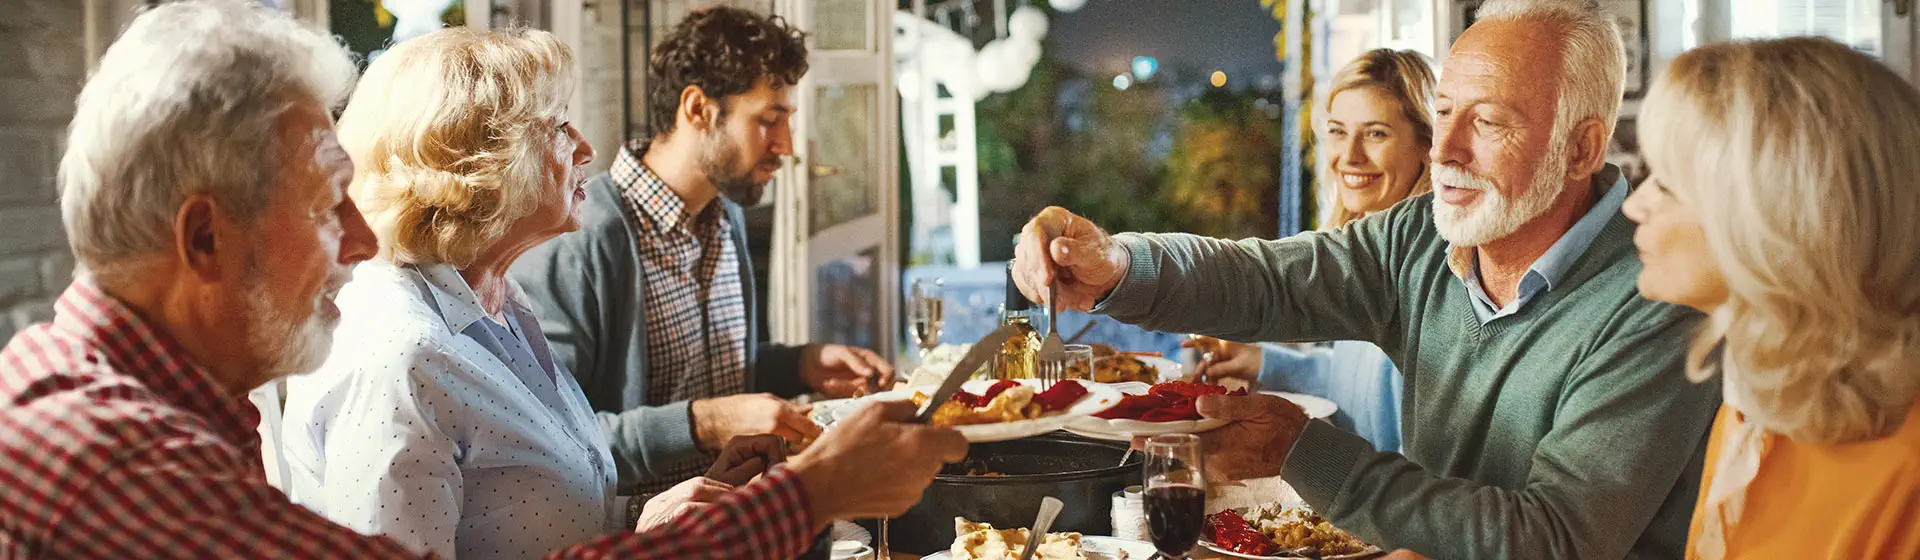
{"left": 340, "top": 27, "right": 574, "bottom": 267}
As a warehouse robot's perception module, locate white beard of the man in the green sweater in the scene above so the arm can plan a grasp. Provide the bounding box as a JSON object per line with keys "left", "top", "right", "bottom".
{"left": 1432, "top": 150, "right": 1567, "bottom": 247}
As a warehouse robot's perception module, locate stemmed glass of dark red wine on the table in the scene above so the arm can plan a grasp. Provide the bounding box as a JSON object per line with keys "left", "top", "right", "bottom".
{"left": 1144, "top": 433, "right": 1206, "bottom": 560}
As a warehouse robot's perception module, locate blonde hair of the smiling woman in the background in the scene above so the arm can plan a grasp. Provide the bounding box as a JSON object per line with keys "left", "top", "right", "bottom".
{"left": 1315, "top": 48, "right": 1434, "bottom": 230}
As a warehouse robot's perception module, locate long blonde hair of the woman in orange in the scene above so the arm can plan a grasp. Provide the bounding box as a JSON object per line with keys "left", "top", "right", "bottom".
{"left": 1640, "top": 38, "right": 1920, "bottom": 443}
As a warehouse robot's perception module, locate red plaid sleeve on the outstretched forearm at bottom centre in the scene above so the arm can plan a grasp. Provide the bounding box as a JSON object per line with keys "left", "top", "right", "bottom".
{"left": 547, "top": 466, "right": 814, "bottom": 558}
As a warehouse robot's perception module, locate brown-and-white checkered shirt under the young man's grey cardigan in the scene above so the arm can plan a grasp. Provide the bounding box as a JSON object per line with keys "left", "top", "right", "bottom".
{"left": 609, "top": 144, "right": 747, "bottom": 493}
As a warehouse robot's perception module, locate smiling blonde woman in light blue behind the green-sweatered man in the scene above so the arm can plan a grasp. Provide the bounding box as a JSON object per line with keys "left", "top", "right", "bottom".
{"left": 1187, "top": 48, "right": 1434, "bottom": 451}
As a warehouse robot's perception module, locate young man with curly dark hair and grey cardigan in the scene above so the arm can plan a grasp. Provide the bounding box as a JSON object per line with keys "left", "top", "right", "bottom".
{"left": 513, "top": 6, "right": 893, "bottom": 495}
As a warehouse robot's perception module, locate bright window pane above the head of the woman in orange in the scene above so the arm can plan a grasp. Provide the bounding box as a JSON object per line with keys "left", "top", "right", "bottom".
{"left": 1730, "top": 0, "right": 1882, "bottom": 56}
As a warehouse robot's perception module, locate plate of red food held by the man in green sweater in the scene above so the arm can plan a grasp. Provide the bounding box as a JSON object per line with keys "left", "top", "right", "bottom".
{"left": 1068, "top": 382, "right": 1246, "bottom": 439}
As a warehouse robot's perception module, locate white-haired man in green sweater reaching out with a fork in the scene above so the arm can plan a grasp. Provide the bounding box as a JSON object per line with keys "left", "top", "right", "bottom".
{"left": 1016, "top": 0, "right": 1720, "bottom": 558}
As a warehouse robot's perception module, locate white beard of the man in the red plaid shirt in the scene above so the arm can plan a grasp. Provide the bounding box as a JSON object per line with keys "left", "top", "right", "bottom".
{"left": 246, "top": 264, "right": 346, "bottom": 378}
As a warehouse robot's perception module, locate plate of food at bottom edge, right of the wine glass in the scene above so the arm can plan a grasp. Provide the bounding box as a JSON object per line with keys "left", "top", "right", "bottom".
{"left": 1200, "top": 504, "right": 1380, "bottom": 560}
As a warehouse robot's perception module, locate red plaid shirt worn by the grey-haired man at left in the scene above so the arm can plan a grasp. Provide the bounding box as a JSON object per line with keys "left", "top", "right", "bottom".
{"left": 0, "top": 282, "right": 812, "bottom": 558}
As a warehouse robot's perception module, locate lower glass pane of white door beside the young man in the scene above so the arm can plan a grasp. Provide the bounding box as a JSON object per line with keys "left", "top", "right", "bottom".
{"left": 812, "top": 247, "right": 879, "bottom": 347}
